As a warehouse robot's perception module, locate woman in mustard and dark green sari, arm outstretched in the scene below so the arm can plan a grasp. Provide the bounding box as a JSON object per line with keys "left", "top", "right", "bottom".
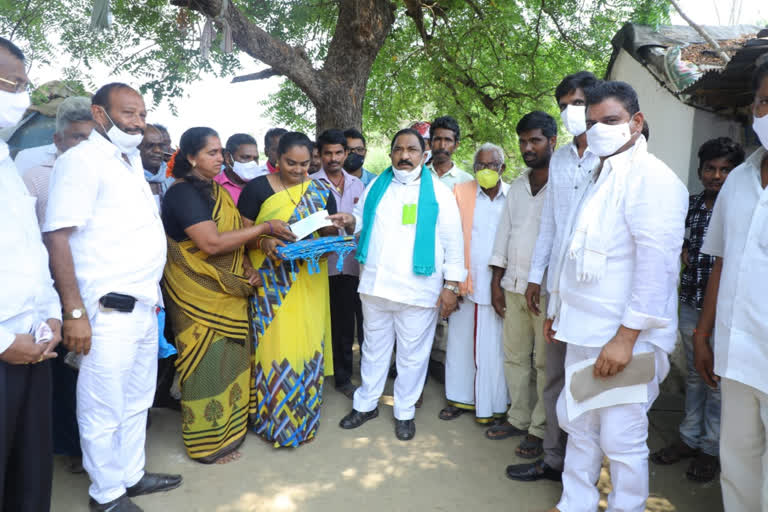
{"left": 162, "top": 128, "right": 293, "bottom": 464}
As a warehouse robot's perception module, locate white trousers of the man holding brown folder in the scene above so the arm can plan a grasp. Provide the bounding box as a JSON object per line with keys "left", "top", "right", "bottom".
{"left": 557, "top": 342, "right": 669, "bottom": 512}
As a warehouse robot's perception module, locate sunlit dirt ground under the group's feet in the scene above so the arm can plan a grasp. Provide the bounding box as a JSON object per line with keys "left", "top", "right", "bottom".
{"left": 53, "top": 379, "right": 722, "bottom": 512}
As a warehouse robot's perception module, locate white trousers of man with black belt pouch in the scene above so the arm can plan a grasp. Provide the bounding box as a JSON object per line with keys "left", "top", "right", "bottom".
{"left": 77, "top": 303, "right": 158, "bottom": 503}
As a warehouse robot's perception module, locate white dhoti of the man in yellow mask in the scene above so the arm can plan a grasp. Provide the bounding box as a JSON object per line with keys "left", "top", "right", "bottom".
{"left": 445, "top": 298, "right": 509, "bottom": 423}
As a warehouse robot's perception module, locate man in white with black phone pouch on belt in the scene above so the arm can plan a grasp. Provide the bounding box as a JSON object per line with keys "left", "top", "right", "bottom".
{"left": 43, "top": 83, "right": 181, "bottom": 512}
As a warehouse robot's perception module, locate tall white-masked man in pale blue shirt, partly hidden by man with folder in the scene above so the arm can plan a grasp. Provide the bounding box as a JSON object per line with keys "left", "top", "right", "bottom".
{"left": 506, "top": 71, "right": 600, "bottom": 482}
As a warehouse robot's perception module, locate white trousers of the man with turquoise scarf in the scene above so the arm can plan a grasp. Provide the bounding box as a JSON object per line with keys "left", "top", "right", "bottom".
{"left": 353, "top": 294, "right": 437, "bottom": 420}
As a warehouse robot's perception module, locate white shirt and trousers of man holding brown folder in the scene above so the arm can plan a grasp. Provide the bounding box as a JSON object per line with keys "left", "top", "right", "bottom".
{"left": 556, "top": 138, "right": 688, "bottom": 512}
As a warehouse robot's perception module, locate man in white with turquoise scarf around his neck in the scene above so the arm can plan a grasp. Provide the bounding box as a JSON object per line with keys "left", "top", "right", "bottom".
{"left": 331, "top": 128, "right": 467, "bottom": 441}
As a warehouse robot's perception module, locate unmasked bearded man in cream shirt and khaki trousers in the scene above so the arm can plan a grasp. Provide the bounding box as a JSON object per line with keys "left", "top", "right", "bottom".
{"left": 485, "top": 111, "right": 557, "bottom": 459}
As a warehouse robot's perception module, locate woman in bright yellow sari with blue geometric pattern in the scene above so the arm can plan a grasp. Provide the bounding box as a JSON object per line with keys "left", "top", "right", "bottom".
{"left": 238, "top": 132, "right": 338, "bottom": 447}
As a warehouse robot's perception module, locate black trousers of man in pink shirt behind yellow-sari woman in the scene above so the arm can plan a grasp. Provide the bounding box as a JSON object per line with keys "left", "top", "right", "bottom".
{"left": 328, "top": 275, "right": 360, "bottom": 387}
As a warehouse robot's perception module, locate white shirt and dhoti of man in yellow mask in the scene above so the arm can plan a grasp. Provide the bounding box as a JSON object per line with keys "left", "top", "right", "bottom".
{"left": 445, "top": 183, "right": 509, "bottom": 422}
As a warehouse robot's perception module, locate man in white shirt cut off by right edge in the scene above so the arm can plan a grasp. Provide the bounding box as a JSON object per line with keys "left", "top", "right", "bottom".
{"left": 693, "top": 62, "right": 768, "bottom": 512}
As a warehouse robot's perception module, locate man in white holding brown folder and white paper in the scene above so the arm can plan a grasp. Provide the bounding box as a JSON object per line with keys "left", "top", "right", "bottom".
{"left": 549, "top": 82, "right": 688, "bottom": 512}
